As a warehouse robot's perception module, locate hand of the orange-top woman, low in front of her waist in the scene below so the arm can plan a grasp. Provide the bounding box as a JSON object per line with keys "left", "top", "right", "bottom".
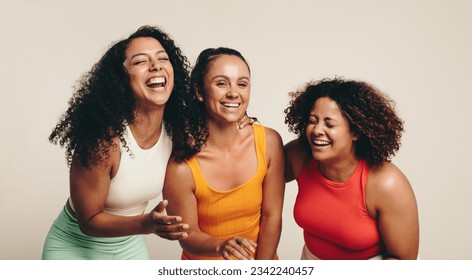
{"left": 218, "top": 236, "right": 257, "bottom": 260}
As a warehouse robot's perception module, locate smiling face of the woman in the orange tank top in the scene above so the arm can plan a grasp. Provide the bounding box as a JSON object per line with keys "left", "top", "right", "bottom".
{"left": 197, "top": 55, "right": 251, "bottom": 122}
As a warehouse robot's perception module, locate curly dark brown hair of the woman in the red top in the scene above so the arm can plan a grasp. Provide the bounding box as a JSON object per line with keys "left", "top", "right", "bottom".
{"left": 284, "top": 77, "right": 403, "bottom": 166}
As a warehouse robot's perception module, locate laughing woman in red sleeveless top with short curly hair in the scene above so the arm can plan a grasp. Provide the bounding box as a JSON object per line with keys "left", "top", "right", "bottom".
{"left": 285, "top": 78, "right": 419, "bottom": 259}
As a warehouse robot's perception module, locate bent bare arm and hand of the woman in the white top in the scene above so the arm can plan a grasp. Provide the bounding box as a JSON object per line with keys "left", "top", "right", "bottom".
{"left": 70, "top": 143, "right": 186, "bottom": 239}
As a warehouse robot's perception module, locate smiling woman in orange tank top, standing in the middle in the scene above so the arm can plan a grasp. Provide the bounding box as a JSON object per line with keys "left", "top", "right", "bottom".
{"left": 163, "top": 48, "right": 285, "bottom": 260}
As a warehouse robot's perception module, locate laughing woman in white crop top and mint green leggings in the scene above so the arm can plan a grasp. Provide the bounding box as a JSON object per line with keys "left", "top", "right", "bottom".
{"left": 43, "top": 26, "right": 193, "bottom": 259}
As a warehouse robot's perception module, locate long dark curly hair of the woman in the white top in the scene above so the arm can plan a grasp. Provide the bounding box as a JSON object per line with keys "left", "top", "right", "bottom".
{"left": 49, "top": 25, "right": 190, "bottom": 168}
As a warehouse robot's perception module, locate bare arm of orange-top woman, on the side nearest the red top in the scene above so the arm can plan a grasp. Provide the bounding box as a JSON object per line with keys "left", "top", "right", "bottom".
{"left": 256, "top": 128, "right": 285, "bottom": 260}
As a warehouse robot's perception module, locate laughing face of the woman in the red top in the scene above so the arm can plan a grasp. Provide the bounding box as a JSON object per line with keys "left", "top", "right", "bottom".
{"left": 306, "top": 97, "right": 357, "bottom": 162}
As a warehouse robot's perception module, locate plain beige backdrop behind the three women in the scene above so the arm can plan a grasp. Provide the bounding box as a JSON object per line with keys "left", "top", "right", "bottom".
{"left": 0, "top": 0, "right": 472, "bottom": 259}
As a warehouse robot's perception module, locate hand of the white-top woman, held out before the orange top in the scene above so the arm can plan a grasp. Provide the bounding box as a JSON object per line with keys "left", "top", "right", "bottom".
{"left": 150, "top": 200, "right": 189, "bottom": 240}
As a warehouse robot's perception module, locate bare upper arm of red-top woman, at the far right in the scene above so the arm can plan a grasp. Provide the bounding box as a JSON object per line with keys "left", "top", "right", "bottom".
{"left": 366, "top": 163, "right": 419, "bottom": 259}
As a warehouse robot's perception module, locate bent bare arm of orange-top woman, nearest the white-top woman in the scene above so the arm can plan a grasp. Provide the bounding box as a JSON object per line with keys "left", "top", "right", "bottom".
{"left": 163, "top": 158, "right": 257, "bottom": 259}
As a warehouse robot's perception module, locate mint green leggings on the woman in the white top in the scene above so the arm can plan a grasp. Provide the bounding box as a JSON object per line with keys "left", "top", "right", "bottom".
{"left": 42, "top": 207, "right": 149, "bottom": 260}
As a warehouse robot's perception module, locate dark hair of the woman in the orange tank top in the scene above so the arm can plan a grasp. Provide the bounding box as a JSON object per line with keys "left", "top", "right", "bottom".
{"left": 174, "top": 47, "right": 251, "bottom": 160}
